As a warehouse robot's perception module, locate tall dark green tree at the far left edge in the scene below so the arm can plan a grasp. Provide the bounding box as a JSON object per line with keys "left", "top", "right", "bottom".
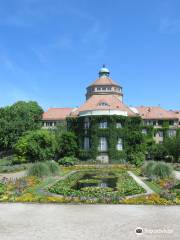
{"left": 0, "top": 101, "right": 43, "bottom": 150}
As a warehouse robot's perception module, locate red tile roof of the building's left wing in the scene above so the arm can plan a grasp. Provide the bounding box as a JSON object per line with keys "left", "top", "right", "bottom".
{"left": 42, "top": 108, "right": 74, "bottom": 120}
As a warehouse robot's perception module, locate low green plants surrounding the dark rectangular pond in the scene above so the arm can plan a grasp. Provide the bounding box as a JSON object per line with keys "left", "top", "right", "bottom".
{"left": 49, "top": 170, "right": 144, "bottom": 202}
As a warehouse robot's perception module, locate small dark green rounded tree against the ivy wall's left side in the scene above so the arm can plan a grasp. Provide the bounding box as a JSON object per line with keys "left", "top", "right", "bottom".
{"left": 58, "top": 132, "right": 78, "bottom": 157}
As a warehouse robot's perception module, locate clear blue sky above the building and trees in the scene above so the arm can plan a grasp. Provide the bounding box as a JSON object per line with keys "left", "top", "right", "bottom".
{"left": 0, "top": 0, "right": 180, "bottom": 109}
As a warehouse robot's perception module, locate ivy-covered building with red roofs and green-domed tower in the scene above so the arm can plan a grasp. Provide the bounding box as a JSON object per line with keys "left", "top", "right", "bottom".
{"left": 43, "top": 66, "right": 180, "bottom": 162}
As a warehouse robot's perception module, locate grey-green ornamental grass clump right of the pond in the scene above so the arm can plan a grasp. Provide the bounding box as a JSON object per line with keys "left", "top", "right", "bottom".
{"left": 143, "top": 161, "right": 173, "bottom": 179}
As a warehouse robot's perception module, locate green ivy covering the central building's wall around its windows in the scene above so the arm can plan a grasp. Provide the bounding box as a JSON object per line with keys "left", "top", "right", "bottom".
{"left": 67, "top": 116, "right": 145, "bottom": 163}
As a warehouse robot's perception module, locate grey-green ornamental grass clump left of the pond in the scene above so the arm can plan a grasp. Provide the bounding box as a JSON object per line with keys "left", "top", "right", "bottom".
{"left": 27, "top": 162, "right": 50, "bottom": 178}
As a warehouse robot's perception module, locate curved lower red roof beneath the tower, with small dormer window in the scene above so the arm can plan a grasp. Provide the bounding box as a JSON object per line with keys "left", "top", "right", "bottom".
{"left": 72, "top": 95, "right": 136, "bottom": 116}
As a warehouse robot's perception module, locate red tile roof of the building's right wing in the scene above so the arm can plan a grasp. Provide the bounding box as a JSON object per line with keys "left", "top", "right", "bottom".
{"left": 136, "top": 106, "right": 178, "bottom": 119}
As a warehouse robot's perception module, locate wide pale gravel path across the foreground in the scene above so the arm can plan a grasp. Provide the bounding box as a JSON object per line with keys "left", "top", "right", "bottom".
{"left": 0, "top": 204, "right": 180, "bottom": 240}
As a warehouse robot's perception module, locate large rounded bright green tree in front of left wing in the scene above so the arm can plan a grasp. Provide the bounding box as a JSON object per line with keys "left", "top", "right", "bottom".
{"left": 14, "top": 130, "right": 56, "bottom": 162}
